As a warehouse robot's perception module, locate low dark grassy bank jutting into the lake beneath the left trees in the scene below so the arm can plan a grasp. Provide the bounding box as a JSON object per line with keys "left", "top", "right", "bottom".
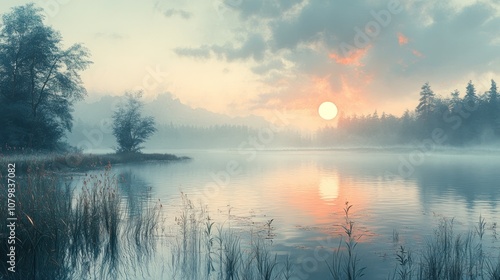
{"left": 0, "top": 153, "right": 189, "bottom": 173}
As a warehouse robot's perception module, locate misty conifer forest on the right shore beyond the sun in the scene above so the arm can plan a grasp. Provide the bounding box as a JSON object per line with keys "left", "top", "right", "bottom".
{"left": 315, "top": 80, "right": 500, "bottom": 146}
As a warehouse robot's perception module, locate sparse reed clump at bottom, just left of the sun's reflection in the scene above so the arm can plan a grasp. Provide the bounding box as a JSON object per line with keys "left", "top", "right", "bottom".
{"left": 169, "top": 193, "right": 282, "bottom": 280}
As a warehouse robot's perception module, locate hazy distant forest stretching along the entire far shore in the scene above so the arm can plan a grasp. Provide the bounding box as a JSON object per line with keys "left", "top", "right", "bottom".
{"left": 69, "top": 80, "right": 500, "bottom": 149}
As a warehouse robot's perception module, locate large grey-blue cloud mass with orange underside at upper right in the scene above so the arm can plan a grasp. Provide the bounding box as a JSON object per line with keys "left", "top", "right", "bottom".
{"left": 270, "top": 1, "right": 500, "bottom": 105}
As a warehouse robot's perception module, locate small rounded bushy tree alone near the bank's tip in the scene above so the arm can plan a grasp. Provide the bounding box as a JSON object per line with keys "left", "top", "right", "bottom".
{"left": 113, "top": 91, "right": 156, "bottom": 153}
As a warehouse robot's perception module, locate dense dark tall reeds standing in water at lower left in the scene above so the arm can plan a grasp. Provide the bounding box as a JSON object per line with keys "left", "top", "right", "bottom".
{"left": 0, "top": 165, "right": 158, "bottom": 280}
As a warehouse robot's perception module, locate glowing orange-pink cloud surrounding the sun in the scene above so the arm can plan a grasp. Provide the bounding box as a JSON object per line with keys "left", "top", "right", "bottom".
{"left": 254, "top": 59, "right": 376, "bottom": 131}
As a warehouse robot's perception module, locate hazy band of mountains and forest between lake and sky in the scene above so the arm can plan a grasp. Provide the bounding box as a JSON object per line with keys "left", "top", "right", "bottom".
{"left": 68, "top": 80, "right": 500, "bottom": 153}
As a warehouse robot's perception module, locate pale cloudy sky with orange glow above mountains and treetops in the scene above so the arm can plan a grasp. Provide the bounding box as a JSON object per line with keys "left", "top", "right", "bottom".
{"left": 0, "top": 0, "right": 500, "bottom": 128}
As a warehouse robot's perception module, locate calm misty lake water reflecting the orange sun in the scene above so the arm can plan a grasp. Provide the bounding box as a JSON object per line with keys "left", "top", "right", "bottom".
{"left": 95, "top": 149, "right": 500, "bottom": 279}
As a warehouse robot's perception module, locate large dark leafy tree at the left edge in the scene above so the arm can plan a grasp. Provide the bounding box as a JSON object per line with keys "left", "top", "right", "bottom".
{"left": 0, "top": 4, "right": 91, "bottom": 150}
